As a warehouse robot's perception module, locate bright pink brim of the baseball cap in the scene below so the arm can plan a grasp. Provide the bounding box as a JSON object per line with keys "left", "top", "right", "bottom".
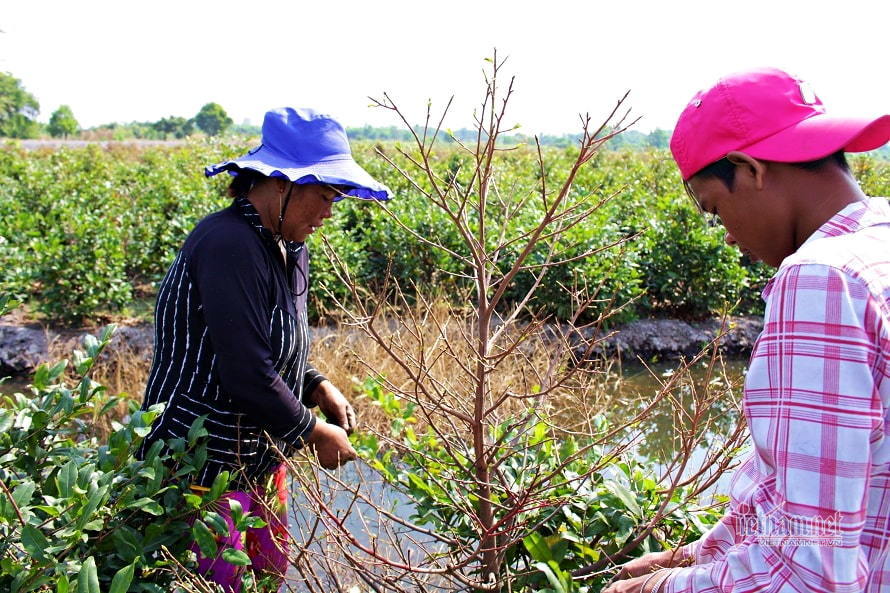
{"left": 739, "top": 114, "right": 890, "bottom": 163}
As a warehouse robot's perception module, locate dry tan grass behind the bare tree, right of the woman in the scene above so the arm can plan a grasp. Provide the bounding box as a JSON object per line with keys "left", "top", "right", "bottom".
{"left": 312, "top": 303, "right": 617, "bottom": 432}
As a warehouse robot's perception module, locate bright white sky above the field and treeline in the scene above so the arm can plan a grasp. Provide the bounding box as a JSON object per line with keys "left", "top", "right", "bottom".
{"left": 0, "top": 0, "right": 890, "bottom": 134}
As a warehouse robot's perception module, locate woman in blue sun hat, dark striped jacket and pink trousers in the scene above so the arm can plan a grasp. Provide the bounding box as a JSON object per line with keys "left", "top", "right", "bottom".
{"left": 142, "top": 108, "right": 390, "bottom": 592}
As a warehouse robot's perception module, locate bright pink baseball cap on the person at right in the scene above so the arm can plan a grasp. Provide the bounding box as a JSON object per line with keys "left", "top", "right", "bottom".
{"left": 671, "top": 68, "right": 890, "bottom": 180}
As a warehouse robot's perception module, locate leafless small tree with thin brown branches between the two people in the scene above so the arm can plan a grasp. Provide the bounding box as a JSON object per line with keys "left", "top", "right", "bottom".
{"left": 280, "top": 53, "right": 742, "bottom": 591}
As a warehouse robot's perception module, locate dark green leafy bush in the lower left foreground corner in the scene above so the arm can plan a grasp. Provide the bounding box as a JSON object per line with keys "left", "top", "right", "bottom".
{"left": 0, "top": 303, "right": 259, "bottom": 593}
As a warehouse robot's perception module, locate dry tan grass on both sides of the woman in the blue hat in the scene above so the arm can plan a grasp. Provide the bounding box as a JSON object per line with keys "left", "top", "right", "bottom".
{"left": 34, "top": 305, "right": 619, "bottom": 434}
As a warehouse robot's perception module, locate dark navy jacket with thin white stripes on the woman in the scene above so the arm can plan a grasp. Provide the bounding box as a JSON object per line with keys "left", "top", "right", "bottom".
{"left": 141, "top": 198, "right": 324, "bottom": 486}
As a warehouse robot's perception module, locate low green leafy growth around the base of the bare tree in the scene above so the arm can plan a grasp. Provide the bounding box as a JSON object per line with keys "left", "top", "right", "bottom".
{"left": 356, "top": 381, "right": 721, "bottom": 593}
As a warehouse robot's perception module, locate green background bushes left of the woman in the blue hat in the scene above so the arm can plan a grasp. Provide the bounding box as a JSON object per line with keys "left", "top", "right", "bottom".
{"left": 0, "top": 144, "right": 234, "bottom": 323}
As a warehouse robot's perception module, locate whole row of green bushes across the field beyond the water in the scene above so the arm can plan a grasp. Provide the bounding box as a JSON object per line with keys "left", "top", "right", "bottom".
{"left": 0, "top": 141, "right": 890, "bottom": 322}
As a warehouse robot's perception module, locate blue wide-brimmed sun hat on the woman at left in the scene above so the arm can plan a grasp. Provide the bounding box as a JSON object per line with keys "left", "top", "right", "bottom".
{"left": 204, "top": 107, "right": 392, "bottom": 200}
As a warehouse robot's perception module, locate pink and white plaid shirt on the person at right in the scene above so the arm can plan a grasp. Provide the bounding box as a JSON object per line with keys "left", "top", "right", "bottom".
{"left": 662, "top": 198, "right": 890, "bottom": 593}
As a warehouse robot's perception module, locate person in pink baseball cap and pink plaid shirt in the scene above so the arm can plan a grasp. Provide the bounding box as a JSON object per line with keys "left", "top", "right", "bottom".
{"left": 606, "top": 68, "right": 890, "bottom": 593}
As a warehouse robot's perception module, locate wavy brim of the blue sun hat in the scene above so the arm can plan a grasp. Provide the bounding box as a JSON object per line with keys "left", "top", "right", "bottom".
{"left": 204, "top": 146, "right": 392, "bottom": 200}
